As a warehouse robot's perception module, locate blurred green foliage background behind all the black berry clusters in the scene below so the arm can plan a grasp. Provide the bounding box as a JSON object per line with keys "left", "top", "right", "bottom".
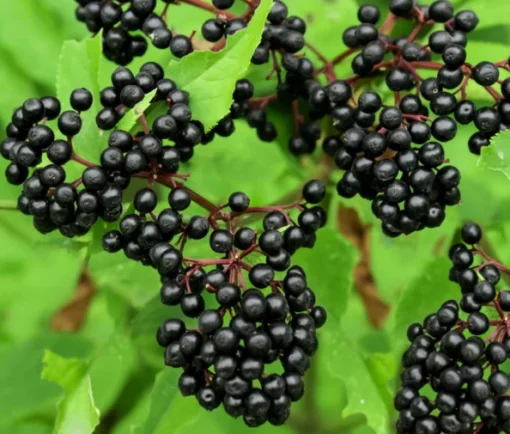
{"left": 0, "top": 0, "right": 510, "bottom": 434}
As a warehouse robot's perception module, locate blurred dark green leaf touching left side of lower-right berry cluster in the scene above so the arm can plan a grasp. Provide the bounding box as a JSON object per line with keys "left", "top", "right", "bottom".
{"left": 394, "top": 257, "right": 461, "bottom": 342}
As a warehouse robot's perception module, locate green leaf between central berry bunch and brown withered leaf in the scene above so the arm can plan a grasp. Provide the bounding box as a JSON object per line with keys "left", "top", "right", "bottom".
{"left": 293, "top": 227, "right": 358, "bottom": 323}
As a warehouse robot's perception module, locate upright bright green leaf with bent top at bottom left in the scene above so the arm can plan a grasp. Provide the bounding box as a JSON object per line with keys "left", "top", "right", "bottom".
{"left": 42, "top": 351, "right": 99, "bottom": 434}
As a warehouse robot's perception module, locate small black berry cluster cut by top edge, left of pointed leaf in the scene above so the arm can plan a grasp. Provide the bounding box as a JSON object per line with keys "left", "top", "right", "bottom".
{"left": 76, "top": 0, "right": 193, "bottom": 65}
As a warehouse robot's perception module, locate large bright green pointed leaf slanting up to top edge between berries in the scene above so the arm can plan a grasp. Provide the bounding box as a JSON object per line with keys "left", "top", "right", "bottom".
{"left": 166, "top": 0, "right": 272, "bottom": 131}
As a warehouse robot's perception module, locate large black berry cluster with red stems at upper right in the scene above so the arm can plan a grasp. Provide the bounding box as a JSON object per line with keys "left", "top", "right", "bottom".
{"left": 240, "top": 0, "right": 510, "bottom": 237}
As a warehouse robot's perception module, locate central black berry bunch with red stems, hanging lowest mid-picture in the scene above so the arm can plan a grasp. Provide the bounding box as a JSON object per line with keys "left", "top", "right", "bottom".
{"left": 103, "top": 181, "right": 326, "bottom": 426}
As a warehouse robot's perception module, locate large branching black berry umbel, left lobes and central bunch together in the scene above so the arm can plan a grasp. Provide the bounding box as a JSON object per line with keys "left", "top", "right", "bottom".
{"left": 0, "top": 47, "right": 326, "bottom": 426}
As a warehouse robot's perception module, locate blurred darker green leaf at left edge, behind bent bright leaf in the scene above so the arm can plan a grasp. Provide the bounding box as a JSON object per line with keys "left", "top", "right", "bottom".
{"left": 0, "top": 333, "right": 91, "bottom": 426}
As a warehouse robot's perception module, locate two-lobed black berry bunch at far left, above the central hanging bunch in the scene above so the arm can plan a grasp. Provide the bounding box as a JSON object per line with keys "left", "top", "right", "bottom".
{"left": 0, "top": 62, "right": 212, "bottom": 237}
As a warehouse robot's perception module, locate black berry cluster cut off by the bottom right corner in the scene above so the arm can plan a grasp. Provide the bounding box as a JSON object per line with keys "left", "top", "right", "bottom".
{"left": 395, "top": 223, "right": 510, "bottom": 434}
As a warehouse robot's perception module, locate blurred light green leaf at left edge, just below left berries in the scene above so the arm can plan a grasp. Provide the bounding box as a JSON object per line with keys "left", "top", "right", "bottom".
{"left": 0, "top": 211, "right": 83, "bottom": 342}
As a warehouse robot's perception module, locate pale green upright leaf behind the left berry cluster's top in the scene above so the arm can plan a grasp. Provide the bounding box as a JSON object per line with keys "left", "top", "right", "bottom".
{"left": 57, "top": 34, "right": 106, "bottom": 162}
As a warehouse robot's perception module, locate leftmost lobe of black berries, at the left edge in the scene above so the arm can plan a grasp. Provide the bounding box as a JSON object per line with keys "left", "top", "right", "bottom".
{"left": 0, "top": 89, "right": 114, "bottom": 236}
